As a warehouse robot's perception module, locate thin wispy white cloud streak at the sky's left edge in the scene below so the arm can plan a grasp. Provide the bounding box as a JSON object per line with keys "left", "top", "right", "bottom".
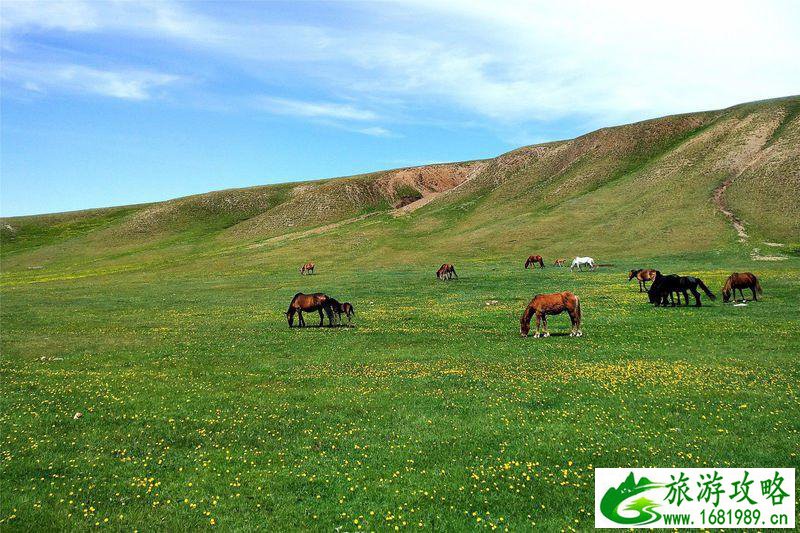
{"left": 2, "top": 62, "right": 180, "bottom": 100}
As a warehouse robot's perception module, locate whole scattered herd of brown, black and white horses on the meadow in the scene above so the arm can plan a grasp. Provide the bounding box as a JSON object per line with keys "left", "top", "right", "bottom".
{"left": 286, "top": 255, "right": 763, "bottom": 337}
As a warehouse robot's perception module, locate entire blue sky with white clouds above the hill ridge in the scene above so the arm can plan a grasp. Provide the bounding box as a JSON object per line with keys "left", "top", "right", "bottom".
{"left": 0, "top": 0, "right": 800, "bottom": 216}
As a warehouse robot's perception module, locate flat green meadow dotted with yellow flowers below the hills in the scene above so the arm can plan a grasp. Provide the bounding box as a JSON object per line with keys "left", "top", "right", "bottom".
{"left": 0, "top": 254, "right": 800, "bottom": 530}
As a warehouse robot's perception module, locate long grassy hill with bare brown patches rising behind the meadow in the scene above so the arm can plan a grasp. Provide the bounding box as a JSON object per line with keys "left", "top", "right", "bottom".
{"left": 0, "top": 96, "right": 800, "bottom": 271}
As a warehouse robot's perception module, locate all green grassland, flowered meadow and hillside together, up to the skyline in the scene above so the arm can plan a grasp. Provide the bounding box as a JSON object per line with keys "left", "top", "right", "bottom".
{"left": 0, "top": 98, "right": 800, "bottom": 531}
